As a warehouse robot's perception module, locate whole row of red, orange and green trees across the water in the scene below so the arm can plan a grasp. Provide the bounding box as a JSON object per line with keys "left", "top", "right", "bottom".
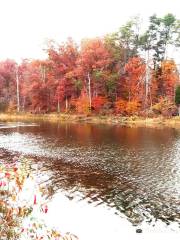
{"left": 0, "top": 14, "right": 180, "bottom": 116}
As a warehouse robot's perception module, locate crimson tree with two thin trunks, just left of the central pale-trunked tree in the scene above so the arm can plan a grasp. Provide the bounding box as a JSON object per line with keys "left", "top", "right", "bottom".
{"left": 47, "top": 39, "right": 81, "bottom": 111}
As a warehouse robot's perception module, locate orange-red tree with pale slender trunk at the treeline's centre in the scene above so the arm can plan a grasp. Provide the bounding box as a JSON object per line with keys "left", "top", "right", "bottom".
{"left": 78, "top": 39, "right": 111, "bottom": 109}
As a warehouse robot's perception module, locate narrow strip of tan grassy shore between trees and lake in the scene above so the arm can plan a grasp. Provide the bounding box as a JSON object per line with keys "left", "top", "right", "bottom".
{"left": 0, "top": 113, "right": 180, "bottom": 129}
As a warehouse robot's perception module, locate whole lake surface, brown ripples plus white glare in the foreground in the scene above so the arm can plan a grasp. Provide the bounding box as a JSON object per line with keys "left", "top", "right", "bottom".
{"left": 0, "top": 122, "right": 180, "bottom": 240}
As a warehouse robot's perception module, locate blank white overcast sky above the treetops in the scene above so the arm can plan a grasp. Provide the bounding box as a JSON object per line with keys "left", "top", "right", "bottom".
{"left": 0, "top": 0, "right": 180, "bottom": 60}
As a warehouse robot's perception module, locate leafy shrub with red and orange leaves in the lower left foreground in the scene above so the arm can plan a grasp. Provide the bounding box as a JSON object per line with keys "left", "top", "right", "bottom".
{"left": 0, "top": 159, "right": 78, "bottom": 240}
